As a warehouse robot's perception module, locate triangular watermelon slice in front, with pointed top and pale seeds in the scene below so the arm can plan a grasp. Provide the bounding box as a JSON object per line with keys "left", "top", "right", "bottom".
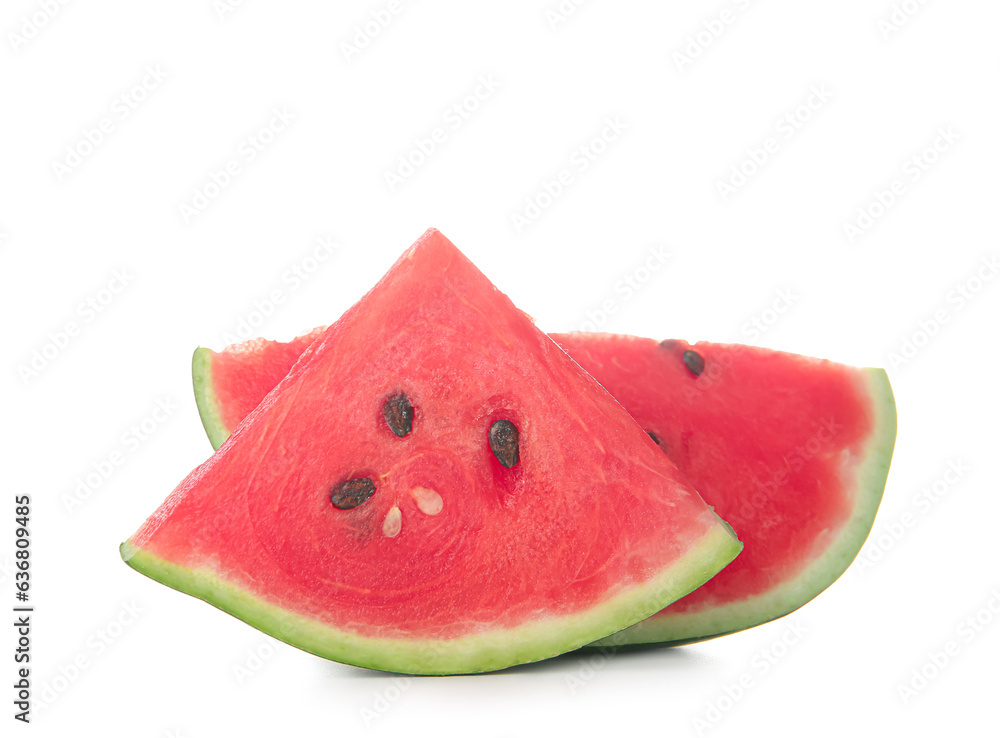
{"left": 121, "top": 230, "right": 741, "bottom": 674}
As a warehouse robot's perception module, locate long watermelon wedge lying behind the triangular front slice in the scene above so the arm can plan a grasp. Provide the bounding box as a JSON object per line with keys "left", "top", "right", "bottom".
{"left": 194, "top": 326, "right": 896, "bottom": 647}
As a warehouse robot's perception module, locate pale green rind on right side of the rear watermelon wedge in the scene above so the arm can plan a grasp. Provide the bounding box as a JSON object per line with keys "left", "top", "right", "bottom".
{"left": 590, "top": 369, "right": 896, "bottom": 649}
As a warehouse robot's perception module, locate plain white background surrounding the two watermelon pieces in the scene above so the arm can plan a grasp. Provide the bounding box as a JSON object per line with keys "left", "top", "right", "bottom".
{"left": 0, "top": 0, "right": 1000, "bottom": 737}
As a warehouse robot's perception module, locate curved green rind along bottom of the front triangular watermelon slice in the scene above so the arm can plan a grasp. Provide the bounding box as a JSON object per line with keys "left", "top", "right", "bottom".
{"left": 121, "top": 525, "right": 743, "bottom": 675}
